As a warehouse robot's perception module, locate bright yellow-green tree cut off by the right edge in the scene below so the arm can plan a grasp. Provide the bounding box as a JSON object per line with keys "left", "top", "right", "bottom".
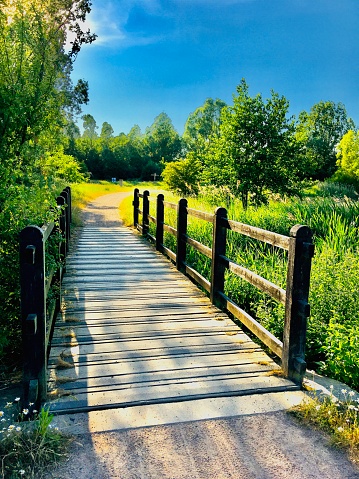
{"left": 334, "top": 130, "right": 359, "bottom": 186}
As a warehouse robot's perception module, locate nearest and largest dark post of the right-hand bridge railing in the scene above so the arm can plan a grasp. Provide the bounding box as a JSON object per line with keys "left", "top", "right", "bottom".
{"left": 282, "top": 225, "right": 314, "bottom": 384}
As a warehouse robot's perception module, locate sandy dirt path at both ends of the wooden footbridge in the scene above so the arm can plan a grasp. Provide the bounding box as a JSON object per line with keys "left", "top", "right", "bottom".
{"left": 46, "top": 193, "right": 359, "bottom": 479}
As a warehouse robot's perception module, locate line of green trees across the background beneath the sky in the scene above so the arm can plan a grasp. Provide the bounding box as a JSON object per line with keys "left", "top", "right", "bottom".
{"left": 65, "top": 84, "right": 359, "bottom": 207}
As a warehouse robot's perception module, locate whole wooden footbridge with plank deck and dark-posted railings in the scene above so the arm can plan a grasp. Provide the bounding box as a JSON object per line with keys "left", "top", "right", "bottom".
{"left": 19, "top": 191, "right": 310, "bottom": 414}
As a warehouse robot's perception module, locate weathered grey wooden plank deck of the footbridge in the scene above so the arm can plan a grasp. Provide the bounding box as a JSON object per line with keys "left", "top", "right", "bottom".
{"left": 47, "top": 226, "right": 298, "bottom": 413}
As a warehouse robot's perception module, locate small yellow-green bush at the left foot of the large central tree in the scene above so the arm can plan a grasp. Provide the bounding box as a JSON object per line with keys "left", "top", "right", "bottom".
{"left": 162, "top": 152, "right": 202, "bottom": 195}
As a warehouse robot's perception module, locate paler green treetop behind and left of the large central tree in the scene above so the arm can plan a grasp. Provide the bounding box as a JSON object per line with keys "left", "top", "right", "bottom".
{"left": 183, "top": 98, "right": 226, "bottom": 150}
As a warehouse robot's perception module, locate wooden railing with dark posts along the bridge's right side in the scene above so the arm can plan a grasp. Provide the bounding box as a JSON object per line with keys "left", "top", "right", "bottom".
{"left": 133, "top": 188, "right": 314, "bottom": 384}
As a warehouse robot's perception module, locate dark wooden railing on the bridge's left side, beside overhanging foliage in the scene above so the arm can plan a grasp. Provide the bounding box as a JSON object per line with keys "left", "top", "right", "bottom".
{"left": 20, "top": 187, "right": 71, "bottom": 407}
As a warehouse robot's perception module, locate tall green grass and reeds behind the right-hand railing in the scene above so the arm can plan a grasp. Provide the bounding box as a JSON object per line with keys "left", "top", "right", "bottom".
{"left": 124, "top": 184, "right": 359, "bottom": 389}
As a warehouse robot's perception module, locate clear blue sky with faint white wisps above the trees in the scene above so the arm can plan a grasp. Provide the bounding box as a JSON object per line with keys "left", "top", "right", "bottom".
{"left": 73, "top": 0, "right": 359, "bottom": 134}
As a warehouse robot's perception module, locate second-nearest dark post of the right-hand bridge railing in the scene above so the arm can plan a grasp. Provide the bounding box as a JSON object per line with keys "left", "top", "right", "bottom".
{"left": 210, "top": 208, "right": 227, "bottom": 307}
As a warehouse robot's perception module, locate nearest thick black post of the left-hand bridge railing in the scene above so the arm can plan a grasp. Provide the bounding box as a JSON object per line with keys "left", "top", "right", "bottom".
{"left": 20, "top": 226, "right": 47, "bottom": 406}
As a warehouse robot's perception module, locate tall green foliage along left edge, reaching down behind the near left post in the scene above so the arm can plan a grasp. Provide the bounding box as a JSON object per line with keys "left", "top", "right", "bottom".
{"left": 0, "top": 0, "right": 95, "bottom": 372}
